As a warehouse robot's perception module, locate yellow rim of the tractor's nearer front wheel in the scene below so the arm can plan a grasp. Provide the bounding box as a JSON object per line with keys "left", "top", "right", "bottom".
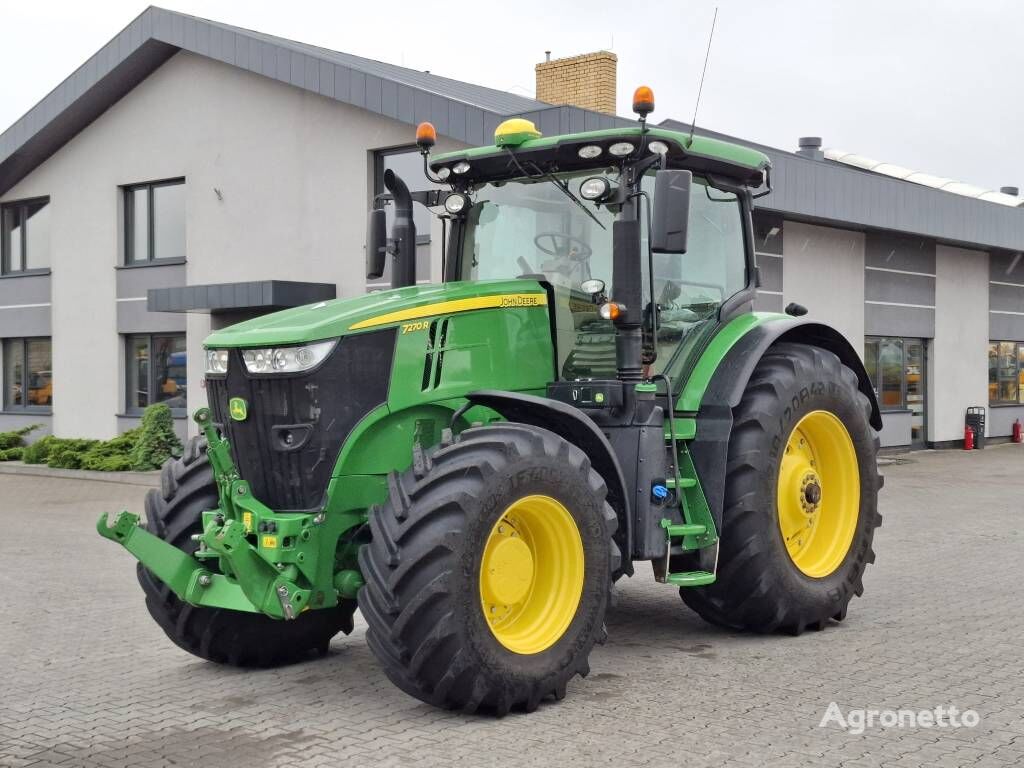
{"left": 480, "top": 496, "right": 584, "bottom": 654}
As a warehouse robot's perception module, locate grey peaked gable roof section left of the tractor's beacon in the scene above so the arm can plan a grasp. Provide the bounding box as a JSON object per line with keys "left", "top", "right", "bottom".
{"left": 0, "top": 6, "right": 618, "bottom": 195}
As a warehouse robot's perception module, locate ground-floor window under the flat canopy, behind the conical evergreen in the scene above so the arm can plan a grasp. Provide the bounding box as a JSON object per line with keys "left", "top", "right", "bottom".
{"left": 125, "top": 334, "right": 188, "bottom": 416}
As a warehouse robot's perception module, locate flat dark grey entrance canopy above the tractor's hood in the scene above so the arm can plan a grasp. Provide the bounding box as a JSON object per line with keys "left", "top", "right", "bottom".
{"left": 145, "top": 280, "right": 338, "bottom": 312}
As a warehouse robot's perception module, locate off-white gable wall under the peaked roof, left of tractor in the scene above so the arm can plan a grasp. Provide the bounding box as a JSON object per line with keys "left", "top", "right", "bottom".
{"left": 3, "top": 53, "right": 454, "bottom": 437}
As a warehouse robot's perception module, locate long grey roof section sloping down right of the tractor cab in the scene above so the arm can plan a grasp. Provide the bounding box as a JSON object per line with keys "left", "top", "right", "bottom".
{"left": 660, "top": 120, "right": 1024, "bottom": 251}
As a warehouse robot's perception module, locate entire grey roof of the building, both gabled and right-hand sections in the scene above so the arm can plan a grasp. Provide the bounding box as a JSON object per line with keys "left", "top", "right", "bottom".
{"left": 0, "top": 6, "right": 1024, "bottom": 251}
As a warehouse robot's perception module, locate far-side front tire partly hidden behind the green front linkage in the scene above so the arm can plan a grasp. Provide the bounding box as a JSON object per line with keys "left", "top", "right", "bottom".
{"left": 138, "top": 437, "right": 355, "bottom": 667}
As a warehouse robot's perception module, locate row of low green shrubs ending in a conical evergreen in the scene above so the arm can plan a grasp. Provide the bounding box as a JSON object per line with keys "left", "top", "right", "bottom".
{"left": 18, "top": 403, "right": 181, "bottom": 472}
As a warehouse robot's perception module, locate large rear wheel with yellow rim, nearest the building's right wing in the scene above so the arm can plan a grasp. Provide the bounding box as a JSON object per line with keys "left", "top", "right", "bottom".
{"left": 680, "top": 343, "right": 882, "bottom": 634}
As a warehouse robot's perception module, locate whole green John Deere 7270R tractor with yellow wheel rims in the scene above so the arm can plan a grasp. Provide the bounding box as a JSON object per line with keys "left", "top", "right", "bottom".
{"left": 97, "top": 88, "right": 882, "bottom": 715}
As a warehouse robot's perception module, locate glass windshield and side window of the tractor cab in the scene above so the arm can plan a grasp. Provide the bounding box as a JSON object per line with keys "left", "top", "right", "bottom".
{"left": 459, "top": 170, "right": 746, "bottom": 378}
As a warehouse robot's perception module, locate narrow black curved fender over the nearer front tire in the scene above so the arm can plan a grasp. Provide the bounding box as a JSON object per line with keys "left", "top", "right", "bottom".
{"left": 466, "top": 389, "right": 633, "bottom": 574}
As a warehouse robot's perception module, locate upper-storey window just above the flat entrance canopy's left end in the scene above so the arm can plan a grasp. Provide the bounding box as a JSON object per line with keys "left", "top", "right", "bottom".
{"left": 124, "top": 178, "right": 185, "bottom": 264}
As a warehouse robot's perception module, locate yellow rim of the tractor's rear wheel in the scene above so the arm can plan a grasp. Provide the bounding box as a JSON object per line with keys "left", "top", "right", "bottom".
{"left": 777, "top": 411, "right": 860, "bottom": 579}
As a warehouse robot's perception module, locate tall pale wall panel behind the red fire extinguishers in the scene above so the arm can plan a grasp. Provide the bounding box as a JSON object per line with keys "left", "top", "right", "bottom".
{"left": 928, "top": 246, "right": 988, "bottom": 442}
